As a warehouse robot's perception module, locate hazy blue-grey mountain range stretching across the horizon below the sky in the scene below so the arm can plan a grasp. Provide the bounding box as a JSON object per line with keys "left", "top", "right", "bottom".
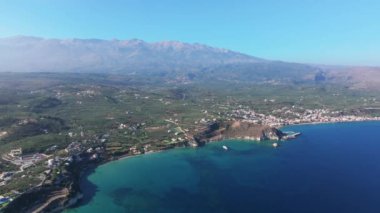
{"left": 0, "top": 36, "right": 380, "bottom": 88}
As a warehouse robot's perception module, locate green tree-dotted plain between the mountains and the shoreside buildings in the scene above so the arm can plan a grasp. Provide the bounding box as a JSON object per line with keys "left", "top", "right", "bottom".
{"left": 0, "top": 73, "right": 380, "bottom": 194}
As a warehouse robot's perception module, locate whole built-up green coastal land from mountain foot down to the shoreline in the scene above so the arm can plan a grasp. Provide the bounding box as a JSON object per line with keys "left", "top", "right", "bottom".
{"left": 0, "top": 72, "right": 380, "bottom": 212}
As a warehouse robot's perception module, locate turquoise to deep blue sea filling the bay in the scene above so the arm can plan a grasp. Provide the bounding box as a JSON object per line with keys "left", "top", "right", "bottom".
{"left": 68, "top": 122, "right": 380, "bottom": 213}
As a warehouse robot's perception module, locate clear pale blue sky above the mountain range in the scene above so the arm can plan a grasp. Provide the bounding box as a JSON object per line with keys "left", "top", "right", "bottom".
{"left": 0, "top": 0, "right": 380, "bottom": 66}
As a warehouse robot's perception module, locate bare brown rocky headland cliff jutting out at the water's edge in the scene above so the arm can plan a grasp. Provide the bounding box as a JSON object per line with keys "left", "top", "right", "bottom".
{"left": 194, "top": 121, "right": 285, "bottom": 145}
